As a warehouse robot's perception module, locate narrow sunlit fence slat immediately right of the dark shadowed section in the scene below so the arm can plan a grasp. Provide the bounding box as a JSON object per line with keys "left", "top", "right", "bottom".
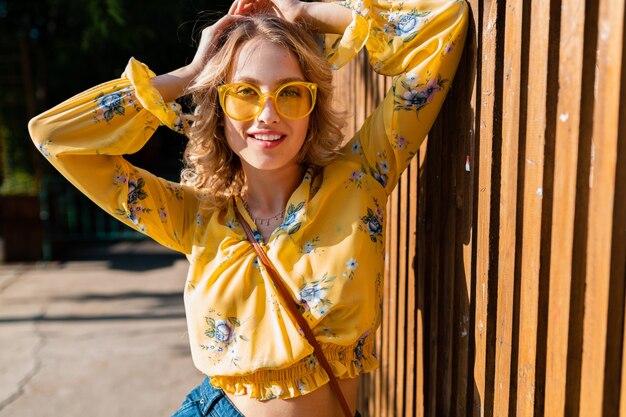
{"left": 473, "top": 0, "right": 498, "bottom": 417}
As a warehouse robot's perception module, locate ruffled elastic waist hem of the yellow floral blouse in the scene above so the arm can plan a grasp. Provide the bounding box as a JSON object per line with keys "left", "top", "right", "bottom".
{"left": 210, "top": 336, "right": 378, "bottom": 401}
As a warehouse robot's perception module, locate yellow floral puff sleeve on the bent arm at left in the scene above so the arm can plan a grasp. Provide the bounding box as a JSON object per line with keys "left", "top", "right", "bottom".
{"left": 29, "top": 59, "right": 199, "bottom": 253}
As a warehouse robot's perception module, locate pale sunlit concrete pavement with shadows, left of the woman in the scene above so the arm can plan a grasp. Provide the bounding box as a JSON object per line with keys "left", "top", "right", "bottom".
{"left": 0, "top": 242, "right": 202, "bottom": 417}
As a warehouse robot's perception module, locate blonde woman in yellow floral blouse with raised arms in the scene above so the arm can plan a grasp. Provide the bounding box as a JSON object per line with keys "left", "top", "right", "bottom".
{"left": 29, "top": 0, "right": 467, "bottom": 417}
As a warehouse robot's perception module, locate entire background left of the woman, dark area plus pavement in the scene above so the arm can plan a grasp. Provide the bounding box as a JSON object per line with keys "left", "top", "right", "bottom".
{"left": 0, "top": 0, "right": 239, "bottom": 417}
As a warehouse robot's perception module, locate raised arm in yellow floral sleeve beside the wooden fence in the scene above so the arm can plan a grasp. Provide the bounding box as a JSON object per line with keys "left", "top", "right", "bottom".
{"left": 327, "top": 0, "right": 468, "bottom": 193}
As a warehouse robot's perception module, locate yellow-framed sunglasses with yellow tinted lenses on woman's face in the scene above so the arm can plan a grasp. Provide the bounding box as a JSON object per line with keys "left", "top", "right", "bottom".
{"left": 217, "top": 81, "right": 317, "bottom": 122}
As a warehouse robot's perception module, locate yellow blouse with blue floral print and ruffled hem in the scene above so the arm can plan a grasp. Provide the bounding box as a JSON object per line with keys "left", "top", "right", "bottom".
{"left": 29, "top": 0, "right": 467, "bottom": 400}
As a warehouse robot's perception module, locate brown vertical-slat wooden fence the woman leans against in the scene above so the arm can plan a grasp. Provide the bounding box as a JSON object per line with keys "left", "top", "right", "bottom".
{"left": 337, "top": 0, "right": 626, "bottom": 417}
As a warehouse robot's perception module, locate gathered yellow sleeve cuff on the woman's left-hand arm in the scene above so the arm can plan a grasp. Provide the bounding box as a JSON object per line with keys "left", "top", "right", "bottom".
{"left": 124, "top": 58, "right": 185, "bottom": 133}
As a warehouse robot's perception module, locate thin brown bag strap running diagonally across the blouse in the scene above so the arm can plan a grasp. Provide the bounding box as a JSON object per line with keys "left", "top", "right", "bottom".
{"left": 235, "top": 206, "right": 353, "bottom": 417}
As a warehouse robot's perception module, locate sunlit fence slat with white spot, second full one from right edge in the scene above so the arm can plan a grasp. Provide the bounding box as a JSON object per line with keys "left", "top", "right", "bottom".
{"left": 544, "top": 0, "right": 585, "bottom": 416}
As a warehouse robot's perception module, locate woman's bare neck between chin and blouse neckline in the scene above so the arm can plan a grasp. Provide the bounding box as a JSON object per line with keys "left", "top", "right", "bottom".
{"left": 243, "top": 164, "right": 305, "bottom": 218}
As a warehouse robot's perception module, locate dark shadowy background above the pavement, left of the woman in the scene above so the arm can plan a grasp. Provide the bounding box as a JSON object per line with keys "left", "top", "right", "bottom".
{"left": 0, "top": 0, "right": 230, "bottom": 262}
